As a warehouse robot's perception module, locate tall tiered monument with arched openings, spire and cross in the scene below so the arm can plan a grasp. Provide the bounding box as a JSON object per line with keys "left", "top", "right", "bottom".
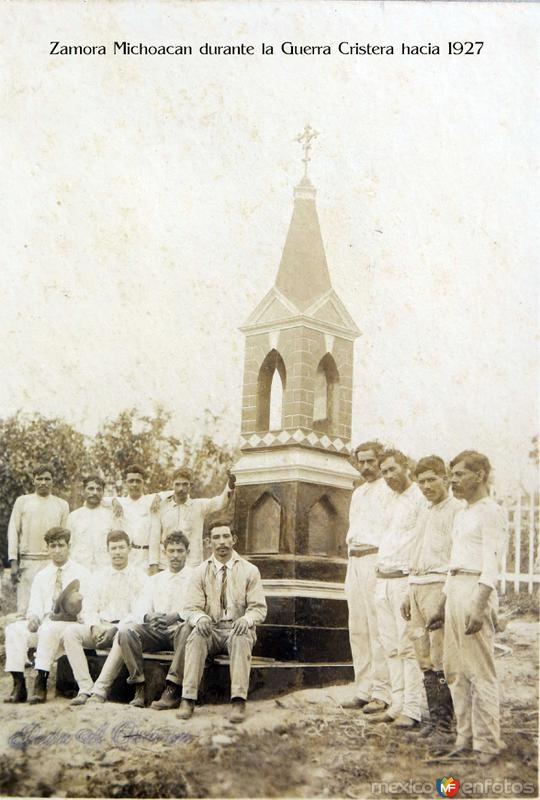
{"left": 233, "top": 126, "right": 360, "bottom": 684}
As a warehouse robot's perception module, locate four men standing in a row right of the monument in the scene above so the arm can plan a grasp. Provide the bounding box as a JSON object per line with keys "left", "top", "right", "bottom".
{"left": 344, "top": 441, "right": 506, "bottom": 765}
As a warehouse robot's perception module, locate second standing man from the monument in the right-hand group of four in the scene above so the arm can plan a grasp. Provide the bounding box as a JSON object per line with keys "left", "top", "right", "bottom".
{"left": 375, "top": 450, "right": 427, "bottom": 728}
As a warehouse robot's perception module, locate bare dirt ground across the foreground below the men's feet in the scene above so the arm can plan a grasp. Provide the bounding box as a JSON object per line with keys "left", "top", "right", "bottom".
{"left": 0, "top": 618, "right": 538, "bottom": 800}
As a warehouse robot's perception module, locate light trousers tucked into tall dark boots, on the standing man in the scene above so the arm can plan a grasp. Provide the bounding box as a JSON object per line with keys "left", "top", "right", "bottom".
{"left": 409, "top": 581, "right": 444, "bottom": 672}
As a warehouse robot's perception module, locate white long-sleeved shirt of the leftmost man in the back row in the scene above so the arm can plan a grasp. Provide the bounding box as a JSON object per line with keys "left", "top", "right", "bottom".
{"left": 8, "top": 492, "right": 69, "bottom": 561}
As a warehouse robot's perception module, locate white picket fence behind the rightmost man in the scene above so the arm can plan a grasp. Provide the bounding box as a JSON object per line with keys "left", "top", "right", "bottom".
{"left": 497, "top": 492, "right": 540, "bottom": 594}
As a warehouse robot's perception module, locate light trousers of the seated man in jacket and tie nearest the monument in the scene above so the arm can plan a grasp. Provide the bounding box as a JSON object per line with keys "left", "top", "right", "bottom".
{"left": 182, "top": 623, "right": 257, "bottom": 700}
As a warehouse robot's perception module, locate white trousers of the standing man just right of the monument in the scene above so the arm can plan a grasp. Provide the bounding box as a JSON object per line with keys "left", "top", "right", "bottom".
{"left": 345, "top": 553, "right": 392, "bottom": 705}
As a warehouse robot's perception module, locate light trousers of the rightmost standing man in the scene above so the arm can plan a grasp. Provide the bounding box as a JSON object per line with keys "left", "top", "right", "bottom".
{"left": 444, "top": 575, "right": 501, "bottom": 753}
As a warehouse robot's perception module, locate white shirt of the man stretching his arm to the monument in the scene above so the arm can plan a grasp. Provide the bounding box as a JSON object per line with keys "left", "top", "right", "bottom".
{"left": 149, "top": 486, "right": 229, "bottom": 567}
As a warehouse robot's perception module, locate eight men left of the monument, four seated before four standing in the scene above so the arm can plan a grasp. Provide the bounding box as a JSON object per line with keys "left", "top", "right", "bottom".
{"left": 5, "top": 465, "right": 266, "bottom": 722}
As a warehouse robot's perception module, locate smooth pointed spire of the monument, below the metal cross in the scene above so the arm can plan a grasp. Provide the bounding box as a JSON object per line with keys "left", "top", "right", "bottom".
{"left": 275, "top": 176, "right": 332, "bottom": 311}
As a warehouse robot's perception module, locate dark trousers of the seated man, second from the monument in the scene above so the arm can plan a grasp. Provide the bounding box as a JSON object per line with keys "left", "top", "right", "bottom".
{"left": 118, "top": 622, "right": 192, "bottom": 686}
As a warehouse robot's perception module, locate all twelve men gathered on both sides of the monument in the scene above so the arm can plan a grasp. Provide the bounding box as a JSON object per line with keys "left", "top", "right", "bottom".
{"left": 2, "top": 441, "right": 506, "bottom": 764}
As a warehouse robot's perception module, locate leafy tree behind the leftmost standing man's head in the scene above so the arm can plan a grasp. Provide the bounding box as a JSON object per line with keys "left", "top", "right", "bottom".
{"left": 0, "top": 412, "right": 87, "bottom": 555}
